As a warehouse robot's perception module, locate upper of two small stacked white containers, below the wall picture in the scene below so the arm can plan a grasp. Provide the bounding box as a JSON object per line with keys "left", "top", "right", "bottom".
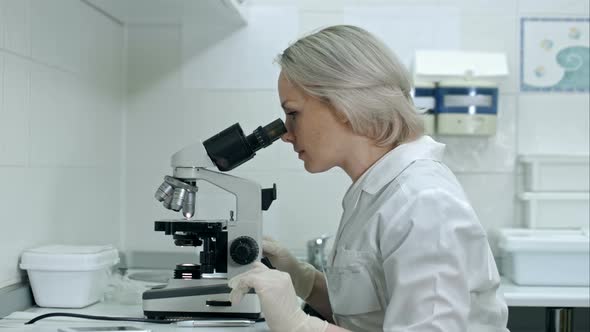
{"left": 519, "top": 155, "right": 590, "bottom": 192}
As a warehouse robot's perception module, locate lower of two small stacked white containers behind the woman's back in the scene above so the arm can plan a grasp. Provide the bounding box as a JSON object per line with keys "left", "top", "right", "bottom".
{"left": 518, "top": 192, "right": 590, "bottom": 228}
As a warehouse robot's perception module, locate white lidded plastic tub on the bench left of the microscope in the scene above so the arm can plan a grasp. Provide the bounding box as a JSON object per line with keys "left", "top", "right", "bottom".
{"left": 20, "top": 245, "right": 119, "bottom": 308}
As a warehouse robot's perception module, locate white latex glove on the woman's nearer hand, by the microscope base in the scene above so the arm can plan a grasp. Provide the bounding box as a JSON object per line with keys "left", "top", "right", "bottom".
{"left": 228, "top": 262, "right": 328, "bottom": 332}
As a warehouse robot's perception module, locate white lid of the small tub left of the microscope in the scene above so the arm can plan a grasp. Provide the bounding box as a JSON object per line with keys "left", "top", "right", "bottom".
{"left": 20, "top": 245, "right": 119, "bottom": 271}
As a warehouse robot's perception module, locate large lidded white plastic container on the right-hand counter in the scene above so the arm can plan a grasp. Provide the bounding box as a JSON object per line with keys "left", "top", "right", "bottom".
{"left": 498, "top": 229, "right": 590, "bottom": 287}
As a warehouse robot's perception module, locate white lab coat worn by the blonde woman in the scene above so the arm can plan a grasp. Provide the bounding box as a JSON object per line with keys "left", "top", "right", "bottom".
{"left": 324, "top": 136, "right": 508, "bottom": 332}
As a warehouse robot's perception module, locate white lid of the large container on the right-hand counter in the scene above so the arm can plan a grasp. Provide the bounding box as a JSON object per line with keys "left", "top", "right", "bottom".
{"left": 498, "top": 228, "right": 590, "bottom": 253}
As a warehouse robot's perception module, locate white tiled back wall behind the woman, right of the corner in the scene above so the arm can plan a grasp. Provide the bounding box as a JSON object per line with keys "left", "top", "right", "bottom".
{"left": 125, "top": 0, "right": 589, "bottom": 253}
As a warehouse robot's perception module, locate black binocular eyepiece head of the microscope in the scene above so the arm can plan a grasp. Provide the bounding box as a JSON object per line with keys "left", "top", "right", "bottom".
{"left": 203, "top": 119, "right": 287, "bottom": 171}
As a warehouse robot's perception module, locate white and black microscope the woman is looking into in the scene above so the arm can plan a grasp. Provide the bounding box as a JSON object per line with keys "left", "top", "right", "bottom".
{"left": 143, "top": 119, "right": 287, "bottom": 319}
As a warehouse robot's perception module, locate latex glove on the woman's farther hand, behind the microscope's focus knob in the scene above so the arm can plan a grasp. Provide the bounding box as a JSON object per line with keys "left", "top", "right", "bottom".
{"left": 262, "top": 236, "right": 321, "bottom": 300}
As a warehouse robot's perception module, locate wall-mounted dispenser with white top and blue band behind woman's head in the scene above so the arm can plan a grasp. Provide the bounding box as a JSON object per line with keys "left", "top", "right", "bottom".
{"left": 414, "top": 51, "right": 508, "bottom": 136}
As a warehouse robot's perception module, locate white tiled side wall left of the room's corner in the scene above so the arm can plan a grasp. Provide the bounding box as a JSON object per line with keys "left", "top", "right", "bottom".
{"left": 0, "top": 0, "right": 124, "bottom": 288}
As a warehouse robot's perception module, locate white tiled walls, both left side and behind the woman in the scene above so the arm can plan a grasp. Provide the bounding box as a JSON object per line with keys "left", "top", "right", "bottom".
{"left": 0, "top": 0, "right": 589, "bottom": 287}
